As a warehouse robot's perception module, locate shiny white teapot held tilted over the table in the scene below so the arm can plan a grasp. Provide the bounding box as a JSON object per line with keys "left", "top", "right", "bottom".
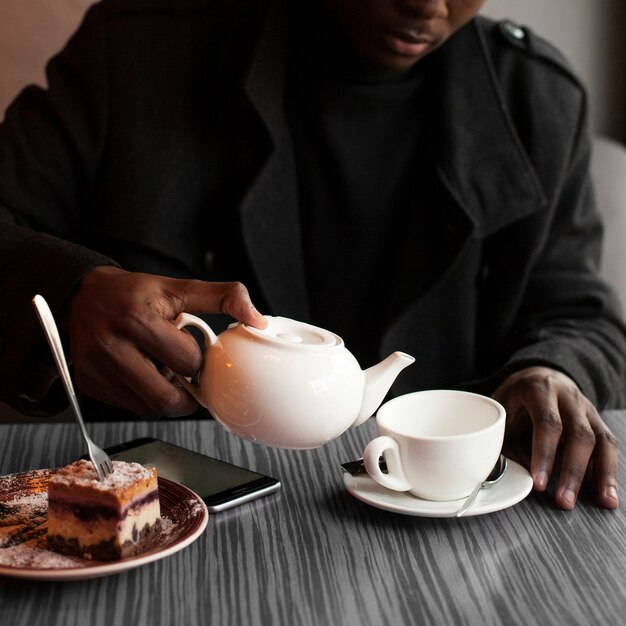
{"left": 176, "top": 313, "right": 415, "bottom": 449}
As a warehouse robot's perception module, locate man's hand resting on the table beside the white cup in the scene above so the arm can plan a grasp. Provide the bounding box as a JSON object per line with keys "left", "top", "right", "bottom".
{"left": 493, "top": 367, "right": 618, "bottom": 509}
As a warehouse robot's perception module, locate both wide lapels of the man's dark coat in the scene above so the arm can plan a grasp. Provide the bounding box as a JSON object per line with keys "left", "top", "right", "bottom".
{"left": 241, "top": 3, "right": 546, "bottom": 312}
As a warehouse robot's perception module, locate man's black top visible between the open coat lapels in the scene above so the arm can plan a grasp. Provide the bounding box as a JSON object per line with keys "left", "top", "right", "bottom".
{"left": 286, "top": 17, "right": 429, "bottom": 366}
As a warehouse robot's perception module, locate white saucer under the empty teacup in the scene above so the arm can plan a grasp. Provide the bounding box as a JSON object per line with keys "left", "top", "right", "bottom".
{"left": 343, "top": 459, "right": 533, "bottom": 517}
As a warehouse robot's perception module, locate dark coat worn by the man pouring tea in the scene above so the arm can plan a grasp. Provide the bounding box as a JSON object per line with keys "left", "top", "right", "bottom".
{"left": 0, "top": 0, "right": 626, "bottom": 420}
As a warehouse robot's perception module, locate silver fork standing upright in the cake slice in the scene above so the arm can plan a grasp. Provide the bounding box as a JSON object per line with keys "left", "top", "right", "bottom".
{"left": 33, "top": 295, "right": 113, "bottom": 481}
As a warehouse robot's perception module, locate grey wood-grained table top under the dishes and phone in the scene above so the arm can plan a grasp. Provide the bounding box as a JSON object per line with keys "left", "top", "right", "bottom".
{"left": 0, "top": 411, "right": 626, "bottom": 626}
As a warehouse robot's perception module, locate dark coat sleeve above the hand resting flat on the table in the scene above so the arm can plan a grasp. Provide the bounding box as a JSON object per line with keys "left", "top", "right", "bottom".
{"left": 478, "top": 94, "right": 626, "bottom": 408}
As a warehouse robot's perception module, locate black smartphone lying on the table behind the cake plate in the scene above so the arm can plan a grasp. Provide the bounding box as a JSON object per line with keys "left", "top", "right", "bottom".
{"left": 95, "top": 437, "right": 280, "bottom": 513}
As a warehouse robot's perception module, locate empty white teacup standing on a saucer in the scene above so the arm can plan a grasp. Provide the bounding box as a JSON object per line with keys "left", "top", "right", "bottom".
{"left": 363, "top": 390, "right": 506, "bottom": 501}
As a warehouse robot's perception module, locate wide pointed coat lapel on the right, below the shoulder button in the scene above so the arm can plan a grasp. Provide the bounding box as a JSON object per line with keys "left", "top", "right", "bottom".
{"left": 434, "top": 19, "right": 546, "bottom": 237}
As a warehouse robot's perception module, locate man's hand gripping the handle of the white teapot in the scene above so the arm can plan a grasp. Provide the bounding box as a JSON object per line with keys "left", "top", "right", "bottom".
{"left": 64, "top": 267, "right": 267, "bottom": 416}
